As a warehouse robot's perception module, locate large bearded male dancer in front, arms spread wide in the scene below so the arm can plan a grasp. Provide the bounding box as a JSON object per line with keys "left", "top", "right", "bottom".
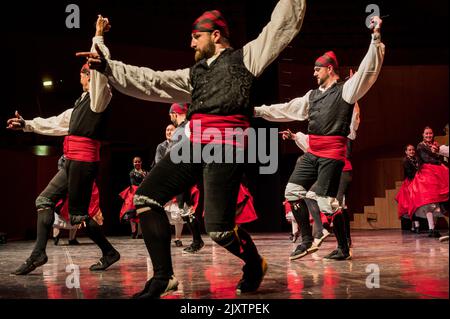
{"left": 80, "top": 0, "right": 306, "bottom": 298}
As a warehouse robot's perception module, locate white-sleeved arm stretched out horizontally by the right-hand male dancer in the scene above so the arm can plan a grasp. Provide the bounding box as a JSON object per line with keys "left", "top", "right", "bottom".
{"left": 255, "top": 91, "right": 311, "bottom": 122}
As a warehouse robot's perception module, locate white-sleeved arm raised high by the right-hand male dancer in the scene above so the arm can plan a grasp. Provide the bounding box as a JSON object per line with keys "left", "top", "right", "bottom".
{"left": 342, "top": 17, "right": 385, "bottom": 104}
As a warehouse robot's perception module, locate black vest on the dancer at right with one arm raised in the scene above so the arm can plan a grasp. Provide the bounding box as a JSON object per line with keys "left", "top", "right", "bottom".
{"left": 308, "top": 82, "right": 354, "bottom": 136}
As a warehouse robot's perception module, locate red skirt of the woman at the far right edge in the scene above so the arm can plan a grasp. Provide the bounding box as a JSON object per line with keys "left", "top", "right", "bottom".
{"left": 408, "top": 164, "right": 449, "bottom": 217}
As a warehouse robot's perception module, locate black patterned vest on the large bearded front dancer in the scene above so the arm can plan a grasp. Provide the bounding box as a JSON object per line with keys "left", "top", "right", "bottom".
{"left": 187, "top": 49, "right": 255, "bottom": 119}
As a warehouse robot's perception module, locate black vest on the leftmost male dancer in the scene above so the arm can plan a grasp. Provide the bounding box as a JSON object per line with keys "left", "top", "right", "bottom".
{"left": 69, "top": 93, "right": 105, "bottom": 140}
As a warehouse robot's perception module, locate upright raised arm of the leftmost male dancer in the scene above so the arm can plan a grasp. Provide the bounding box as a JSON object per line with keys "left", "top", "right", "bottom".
{"left": 89, "top": 15, "right": 112, "bottom": 113}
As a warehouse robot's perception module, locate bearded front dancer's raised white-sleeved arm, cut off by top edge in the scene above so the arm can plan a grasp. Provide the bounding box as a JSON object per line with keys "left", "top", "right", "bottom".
{"left": 243, "top": 0, "right": 306, "bottom": 76}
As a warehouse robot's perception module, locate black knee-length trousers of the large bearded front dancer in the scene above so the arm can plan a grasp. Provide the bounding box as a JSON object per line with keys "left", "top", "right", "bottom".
{"left": 134, "top": 141, "right": 244, "bottom": 232}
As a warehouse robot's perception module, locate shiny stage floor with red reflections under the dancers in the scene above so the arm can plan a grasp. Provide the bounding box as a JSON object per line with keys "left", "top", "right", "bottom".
{"left": 0, "top": 230, "right": 449, "bottom": 299}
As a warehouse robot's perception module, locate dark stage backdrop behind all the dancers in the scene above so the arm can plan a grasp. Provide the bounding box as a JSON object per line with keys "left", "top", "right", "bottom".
{"left": 0, "top": 0, "right": 448, "bottom": 239}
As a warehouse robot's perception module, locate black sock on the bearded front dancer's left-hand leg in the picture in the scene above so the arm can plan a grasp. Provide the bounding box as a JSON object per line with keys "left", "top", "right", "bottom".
{"left": 137, "top": 207, "right": 173, "bottom": 280}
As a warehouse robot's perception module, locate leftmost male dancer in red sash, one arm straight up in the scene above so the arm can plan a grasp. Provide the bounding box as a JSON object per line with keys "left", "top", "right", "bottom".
{"left": 7, "top": 15, "right": 120, "bottom": 275}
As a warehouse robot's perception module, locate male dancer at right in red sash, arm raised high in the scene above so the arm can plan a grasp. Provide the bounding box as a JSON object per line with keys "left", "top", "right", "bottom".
{"left": 255, "top": 17, "right": 384, "bottom": 260}
